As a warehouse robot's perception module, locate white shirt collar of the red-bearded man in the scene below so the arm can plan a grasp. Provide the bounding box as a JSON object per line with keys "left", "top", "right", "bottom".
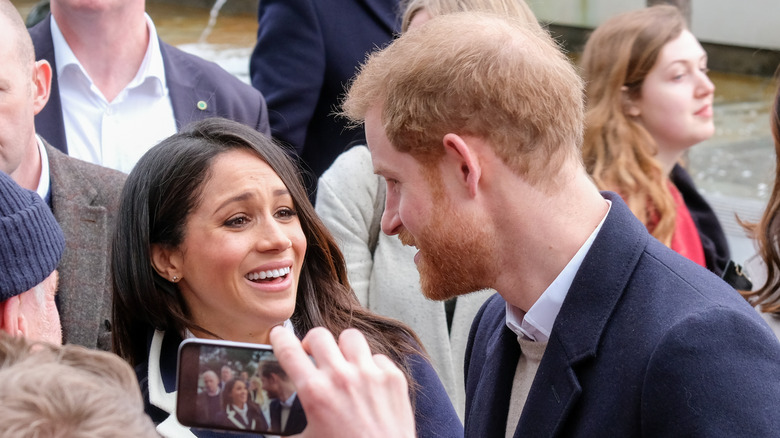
{"left": 506, "top": 199, "right": 612, "bottom": 342}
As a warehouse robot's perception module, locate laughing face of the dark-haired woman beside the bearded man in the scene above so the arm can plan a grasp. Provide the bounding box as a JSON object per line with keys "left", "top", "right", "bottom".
{"left": 155, "top": 150, "right": 306, "bottom": 343}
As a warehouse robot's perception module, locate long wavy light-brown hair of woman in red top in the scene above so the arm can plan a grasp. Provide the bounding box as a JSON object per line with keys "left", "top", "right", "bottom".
{"left": 582, "top": 5, "right": 686, "bottom": 246}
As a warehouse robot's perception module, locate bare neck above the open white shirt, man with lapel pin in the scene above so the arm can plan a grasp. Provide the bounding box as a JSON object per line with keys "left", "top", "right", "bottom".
{"left": 52, "top": 1, "right": 149, "bottom": 102}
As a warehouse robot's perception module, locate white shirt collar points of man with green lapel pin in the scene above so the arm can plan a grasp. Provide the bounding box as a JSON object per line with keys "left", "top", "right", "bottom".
{"left": 51, "top": 13, "right": 167, "bottom": 96}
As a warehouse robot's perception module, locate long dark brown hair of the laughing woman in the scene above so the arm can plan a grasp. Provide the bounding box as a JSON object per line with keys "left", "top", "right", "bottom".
{"left": 111, "top": 118, "right": 424, "bottom": 387}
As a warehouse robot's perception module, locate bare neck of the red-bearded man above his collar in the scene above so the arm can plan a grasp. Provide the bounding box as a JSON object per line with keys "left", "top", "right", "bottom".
{"left": 494, "top": 166, "right": 609, "bottom": 312}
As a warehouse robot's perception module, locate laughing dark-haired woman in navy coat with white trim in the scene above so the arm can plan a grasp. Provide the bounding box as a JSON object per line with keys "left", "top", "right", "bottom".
{"left": 112, "top": 119, "right": 463, "bottom": 437}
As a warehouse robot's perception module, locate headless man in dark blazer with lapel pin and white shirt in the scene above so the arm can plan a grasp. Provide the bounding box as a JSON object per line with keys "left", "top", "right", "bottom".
{"left": 30, "top": 0, "right": 270, "bottom": 173}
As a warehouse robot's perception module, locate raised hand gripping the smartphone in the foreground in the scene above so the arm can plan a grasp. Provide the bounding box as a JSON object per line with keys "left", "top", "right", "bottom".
{"left": 271, "top": 327, "right": 416, "bottom": 438}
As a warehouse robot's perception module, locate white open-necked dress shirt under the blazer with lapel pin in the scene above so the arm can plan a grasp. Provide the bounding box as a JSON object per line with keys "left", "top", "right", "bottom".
{"left": 51, "top": 15, "right": 176, "bottom": 173}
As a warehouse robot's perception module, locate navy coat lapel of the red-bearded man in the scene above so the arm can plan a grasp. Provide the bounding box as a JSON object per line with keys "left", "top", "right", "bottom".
{"left": 516, "top": 192, "right": 648, "bottom": 437}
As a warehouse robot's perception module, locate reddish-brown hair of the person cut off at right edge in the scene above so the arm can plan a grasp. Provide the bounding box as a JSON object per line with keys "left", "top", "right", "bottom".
{"left": 740, "top": 79, "right": 780, "bottom": 315}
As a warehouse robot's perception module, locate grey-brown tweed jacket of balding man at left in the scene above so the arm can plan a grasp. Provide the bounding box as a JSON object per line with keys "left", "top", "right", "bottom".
{"left": 44, "top": 140, "right": 127, "bottom": 350}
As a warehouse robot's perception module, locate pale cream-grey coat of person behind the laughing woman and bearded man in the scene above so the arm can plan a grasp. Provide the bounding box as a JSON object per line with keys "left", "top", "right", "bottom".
{"left": 316, "top": 146, "right": 493, "bottom": 418}
